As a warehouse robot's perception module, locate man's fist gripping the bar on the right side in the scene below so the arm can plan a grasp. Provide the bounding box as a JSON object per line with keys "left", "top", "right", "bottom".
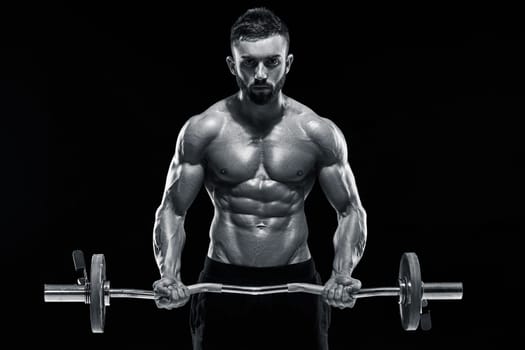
{"left": 323, "top": 275, "right": 361, "bottom": 309}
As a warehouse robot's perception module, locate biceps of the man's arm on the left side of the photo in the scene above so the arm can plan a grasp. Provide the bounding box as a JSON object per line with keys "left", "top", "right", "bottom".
{"left": 162, "top": 162, "right": 204, "bottom": 215}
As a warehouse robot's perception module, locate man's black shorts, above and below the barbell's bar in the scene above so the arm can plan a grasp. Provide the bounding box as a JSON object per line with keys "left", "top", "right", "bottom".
{"left": 190, "top": 258, "right": 330, "bottom": 350}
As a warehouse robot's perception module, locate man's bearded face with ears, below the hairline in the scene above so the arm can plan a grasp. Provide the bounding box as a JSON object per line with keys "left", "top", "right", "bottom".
{"left": 227, "top": 35, "right": 293, "bottom": 105}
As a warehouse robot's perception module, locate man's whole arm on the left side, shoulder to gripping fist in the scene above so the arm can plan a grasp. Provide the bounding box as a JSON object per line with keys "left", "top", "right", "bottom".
{"left": 153, "top": 116, "right": 216, "bottom": 308}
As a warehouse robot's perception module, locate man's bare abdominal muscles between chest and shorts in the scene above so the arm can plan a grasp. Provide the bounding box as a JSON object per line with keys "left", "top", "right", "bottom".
{"left": 208, "top": 185, "right": 311, "bottom": 267}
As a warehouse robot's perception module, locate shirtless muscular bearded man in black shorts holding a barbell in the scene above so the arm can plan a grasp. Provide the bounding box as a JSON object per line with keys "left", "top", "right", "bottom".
{"left": 153, "top": 8, "right": 366, "bottom": 350}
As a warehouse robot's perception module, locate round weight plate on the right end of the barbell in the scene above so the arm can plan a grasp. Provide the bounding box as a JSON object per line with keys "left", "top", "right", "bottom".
{"left": 398, "top": 253, "right": 423, "bottom": 331}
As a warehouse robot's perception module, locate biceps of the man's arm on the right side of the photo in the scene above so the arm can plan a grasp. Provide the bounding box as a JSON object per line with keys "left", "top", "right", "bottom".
{"left": 319, "top": 163, "right": 361, "bottom": 214}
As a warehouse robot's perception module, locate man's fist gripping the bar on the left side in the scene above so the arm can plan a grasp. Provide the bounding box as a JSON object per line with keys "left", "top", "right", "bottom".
{"left": 153, "top": 277, "right": 190, "bottom": 310}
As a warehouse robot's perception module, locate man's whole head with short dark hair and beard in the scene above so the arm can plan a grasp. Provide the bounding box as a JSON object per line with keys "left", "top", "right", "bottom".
{"left": 226, "top": 8, "right": 293, "bottom": 105}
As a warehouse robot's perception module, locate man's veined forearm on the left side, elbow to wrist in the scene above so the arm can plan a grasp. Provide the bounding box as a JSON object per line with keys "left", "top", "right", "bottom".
{"left": 153, "top": 203, "right": 186, "bottom": 281}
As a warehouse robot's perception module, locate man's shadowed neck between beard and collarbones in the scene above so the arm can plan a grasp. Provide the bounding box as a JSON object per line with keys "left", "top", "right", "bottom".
{"left": 237, "top": 91, "right": 286, "bottom": 126}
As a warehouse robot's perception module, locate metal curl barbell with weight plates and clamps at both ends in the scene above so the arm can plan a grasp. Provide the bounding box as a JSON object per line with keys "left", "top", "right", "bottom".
{"left": 44, "top": 250, "right": 463, "bottom": 333}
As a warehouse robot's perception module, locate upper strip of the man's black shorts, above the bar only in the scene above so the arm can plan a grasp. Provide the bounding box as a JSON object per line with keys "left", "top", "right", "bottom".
{"left": 199, "top": 257, "right": 317, "bottom": 286}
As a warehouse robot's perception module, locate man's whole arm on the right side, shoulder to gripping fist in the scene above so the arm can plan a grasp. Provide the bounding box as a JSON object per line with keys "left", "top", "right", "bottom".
{"left": 311, "top": 119, "right": 367, "bottom": 308}
